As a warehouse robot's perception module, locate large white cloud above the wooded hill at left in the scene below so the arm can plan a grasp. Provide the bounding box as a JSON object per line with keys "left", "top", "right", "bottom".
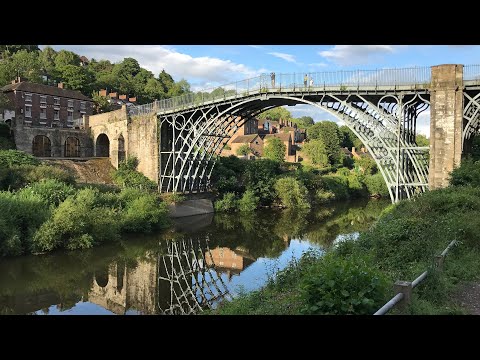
{"left": 41, "top": 45, "right": 266, "bottom": 87}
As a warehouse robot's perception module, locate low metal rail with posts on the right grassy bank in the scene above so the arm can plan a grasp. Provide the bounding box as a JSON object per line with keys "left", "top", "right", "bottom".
{"left": 373, "top": 240, "right": 456, "bottom": 315}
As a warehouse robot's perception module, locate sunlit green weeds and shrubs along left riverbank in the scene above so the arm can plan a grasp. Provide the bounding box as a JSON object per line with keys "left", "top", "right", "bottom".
{"left": 0, "top": 150, "right": 168, "bottom": 256}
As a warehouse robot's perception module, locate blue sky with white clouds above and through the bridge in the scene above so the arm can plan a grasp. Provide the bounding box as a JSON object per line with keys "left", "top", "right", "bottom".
{"left": 40, "top": 45, "right": 480, "bottom": 136}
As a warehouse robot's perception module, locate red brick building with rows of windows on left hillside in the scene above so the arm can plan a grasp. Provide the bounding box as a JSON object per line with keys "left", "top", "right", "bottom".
{"left": 1, "top": 79, "right": 93, "bottom": 128}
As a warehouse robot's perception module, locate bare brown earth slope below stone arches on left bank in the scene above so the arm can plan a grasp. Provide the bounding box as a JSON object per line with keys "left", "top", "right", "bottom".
{"left": 42, "top": 158, "right": 114, "bottom": 184}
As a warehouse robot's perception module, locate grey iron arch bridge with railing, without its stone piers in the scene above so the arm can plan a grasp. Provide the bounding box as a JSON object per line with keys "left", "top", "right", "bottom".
{"left": 131, "top": 65, "right": 480, "bottom": 202}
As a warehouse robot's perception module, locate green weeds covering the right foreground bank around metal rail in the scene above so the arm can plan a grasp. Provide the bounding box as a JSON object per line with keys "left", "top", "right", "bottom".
{"left": 214, "top": 161, "right": 480, "bottom": 314}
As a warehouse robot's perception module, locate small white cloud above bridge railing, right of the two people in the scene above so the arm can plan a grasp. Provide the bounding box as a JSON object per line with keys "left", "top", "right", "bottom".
{"left": 318, "top": 45, "right": 404, "bottom": 65}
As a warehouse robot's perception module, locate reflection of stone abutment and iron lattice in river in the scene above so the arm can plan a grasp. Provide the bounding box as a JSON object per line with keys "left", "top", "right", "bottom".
{"left": 88, "top": 236, "right": 251, "bottom": 315}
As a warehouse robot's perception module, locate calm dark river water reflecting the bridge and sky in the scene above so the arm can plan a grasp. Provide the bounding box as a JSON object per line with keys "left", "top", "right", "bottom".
{"left": 0, "top": 200, "right": 389, "bottom": 315}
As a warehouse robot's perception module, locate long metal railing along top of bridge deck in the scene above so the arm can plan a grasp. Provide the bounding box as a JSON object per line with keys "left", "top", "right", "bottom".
{"left": 131, "top": 66, "right": 434, "bottom": 114}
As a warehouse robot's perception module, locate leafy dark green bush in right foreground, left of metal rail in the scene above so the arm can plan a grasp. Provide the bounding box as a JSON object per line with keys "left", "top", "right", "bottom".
{"left": 300, "top": 253, "right": 388, "bottom": 315}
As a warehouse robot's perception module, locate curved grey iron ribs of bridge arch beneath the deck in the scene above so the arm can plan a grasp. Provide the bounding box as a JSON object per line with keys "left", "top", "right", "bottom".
{"left": 160, "top": 94, "right": 428, "bottom": 201}
